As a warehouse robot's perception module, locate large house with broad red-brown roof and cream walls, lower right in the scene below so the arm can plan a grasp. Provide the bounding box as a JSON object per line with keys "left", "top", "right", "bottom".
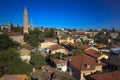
{"left": 70, "top": 54, "right": 105, "bottom": 80}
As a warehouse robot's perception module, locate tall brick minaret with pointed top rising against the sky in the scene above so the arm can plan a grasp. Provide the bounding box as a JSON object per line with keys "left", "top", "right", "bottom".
{"left": 23, "top": 7, "right": 28, "bottom": 34}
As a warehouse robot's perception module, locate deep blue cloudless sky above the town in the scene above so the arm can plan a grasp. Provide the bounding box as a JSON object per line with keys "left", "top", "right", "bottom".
{"left": 0, "top": 0, "right": 120, "bottom": 29}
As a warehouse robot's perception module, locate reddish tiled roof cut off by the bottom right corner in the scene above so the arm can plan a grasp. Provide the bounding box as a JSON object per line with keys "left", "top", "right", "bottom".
{"left": 88, "top": 71, "right": 120, "bottom": 80}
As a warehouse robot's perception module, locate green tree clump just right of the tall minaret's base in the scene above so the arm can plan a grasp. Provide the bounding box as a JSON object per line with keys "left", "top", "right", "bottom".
{"left": 24, "top": 28, "right": 57, "bottom": 47}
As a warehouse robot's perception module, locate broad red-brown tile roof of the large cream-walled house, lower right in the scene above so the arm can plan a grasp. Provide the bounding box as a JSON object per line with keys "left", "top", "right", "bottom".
{"left": 71, "top": 54, "right": 104, "bottom": 70}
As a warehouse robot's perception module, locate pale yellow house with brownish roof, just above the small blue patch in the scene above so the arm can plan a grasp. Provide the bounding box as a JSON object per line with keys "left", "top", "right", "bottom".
{"left": 39, "top": 38, "right": 57, "bottom": 49}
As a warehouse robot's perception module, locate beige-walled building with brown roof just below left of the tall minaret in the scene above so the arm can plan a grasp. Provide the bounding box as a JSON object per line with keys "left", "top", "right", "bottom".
{"left": 7, "top": 32, "right": 26, "bottom": 45}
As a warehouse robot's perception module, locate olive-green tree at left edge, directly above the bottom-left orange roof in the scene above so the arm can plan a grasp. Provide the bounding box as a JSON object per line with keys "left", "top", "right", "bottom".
{"left": 0, "top": 48, "right": 32, "bottom": 76}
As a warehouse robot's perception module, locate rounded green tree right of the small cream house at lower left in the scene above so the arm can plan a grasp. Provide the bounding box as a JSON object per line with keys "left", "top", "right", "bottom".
{"left": 30, "top": 53, "right": 46, "bottom": 69}
